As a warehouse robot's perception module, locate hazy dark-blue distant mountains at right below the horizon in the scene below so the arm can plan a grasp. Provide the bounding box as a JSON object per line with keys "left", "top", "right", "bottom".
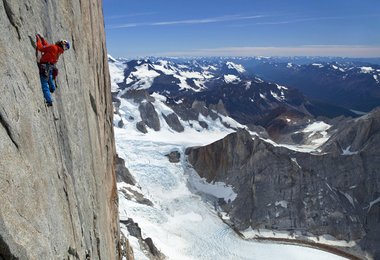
{"left": 243, "top": 60, "right": 380, "bottom": 112}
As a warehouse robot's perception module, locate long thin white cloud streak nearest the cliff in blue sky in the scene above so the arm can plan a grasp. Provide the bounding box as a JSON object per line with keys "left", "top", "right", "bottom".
{"left": 108, "top": 15, "right": 265, "bottom": 29}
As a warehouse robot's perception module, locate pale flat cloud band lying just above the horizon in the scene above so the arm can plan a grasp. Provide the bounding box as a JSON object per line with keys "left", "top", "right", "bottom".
{"left": 155, "top": 45, "right": 380, "bottom": 58}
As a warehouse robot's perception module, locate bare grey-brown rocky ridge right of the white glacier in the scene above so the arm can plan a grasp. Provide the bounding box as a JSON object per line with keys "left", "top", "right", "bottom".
{"left": 187, "top": 110, "right": 380, "bottom": 259}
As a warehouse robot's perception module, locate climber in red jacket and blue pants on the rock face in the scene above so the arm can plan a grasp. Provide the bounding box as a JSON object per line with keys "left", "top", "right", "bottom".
{"left": 36, "top": 34, "right": 70, "bottom": 106}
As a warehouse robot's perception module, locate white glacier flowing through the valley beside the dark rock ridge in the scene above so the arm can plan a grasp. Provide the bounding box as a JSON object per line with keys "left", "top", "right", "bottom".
{"left": 115, "top": 131, "right": 343, "bottom": 260}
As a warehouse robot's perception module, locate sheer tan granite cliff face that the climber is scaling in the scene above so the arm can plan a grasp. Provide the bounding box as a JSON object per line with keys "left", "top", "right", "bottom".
{"left": 0, "top": 0, "right": 119, "bottom": 260}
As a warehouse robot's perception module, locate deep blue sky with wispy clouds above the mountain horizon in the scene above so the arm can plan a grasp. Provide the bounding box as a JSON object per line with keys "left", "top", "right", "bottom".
{"left": 103, "top": 0, "right": 380, "bottom": 57}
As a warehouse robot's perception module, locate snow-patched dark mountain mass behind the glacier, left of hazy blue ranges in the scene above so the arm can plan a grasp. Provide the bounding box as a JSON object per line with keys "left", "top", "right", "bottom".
{"left": 110, "top": 59, "right": 355, "bottom": 142}
